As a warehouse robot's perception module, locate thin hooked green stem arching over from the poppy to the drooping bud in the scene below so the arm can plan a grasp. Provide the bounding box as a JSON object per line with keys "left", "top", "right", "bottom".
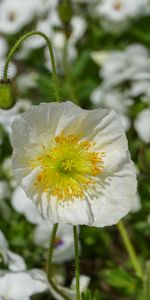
{"left": 4, "top": 31, "right": 60, "bottom": 102}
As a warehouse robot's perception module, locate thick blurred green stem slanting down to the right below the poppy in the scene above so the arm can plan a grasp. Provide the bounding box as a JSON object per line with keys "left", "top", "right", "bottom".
{"left": 117, "top": 221, "right": 144, "bottom": 279}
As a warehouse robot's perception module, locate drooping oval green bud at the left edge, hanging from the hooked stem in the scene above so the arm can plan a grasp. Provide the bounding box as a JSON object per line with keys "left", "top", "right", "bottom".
{"left": 0, "top": 79, "right": 16, "bottom": 109}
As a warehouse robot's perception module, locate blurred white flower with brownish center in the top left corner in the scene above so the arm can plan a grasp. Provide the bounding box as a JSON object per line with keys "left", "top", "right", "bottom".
{"left": 0, "top": 0, "right": 37, "bottom": 34}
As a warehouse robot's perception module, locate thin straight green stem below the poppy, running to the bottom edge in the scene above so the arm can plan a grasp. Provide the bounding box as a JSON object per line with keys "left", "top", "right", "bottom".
{"left": 73, "top": 226, "right": 81, "bottom": 300}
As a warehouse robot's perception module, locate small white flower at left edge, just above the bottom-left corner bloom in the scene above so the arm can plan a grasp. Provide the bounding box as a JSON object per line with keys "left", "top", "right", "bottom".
{"left": 0, "top": 230, "right": 26, "bottom": 272}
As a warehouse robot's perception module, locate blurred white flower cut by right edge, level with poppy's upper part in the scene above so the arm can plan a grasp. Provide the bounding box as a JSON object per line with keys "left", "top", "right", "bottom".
{"left": 134, "top": 108, "right": 150, "bottom": 144}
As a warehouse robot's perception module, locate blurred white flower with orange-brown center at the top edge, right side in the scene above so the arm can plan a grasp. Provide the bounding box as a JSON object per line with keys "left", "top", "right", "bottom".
{"left": 96, "top": 0, "right": 145, "bottom": 32}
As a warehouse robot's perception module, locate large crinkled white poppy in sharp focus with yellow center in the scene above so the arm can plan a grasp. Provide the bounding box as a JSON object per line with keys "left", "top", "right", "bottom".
{"left": 12, "top": 102, "right": 136, "bottom": 227}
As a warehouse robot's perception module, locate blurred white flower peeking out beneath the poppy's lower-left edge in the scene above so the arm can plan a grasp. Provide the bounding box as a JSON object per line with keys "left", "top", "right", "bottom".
{"left": 11, "top": 187, "right": 43, "bottom": 224}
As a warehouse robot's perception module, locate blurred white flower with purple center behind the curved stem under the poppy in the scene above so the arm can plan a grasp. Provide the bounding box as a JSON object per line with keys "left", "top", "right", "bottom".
{"left": 34, "top": 221, "right": 74, "bottom": 263}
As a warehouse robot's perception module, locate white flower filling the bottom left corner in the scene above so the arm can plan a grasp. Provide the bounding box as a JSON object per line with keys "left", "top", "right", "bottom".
{"left": 0, "top": 269, "right": 48, "bottom": 300}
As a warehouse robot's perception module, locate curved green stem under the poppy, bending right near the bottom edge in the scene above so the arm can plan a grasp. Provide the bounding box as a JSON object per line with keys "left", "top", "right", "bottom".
{"left": 47, "top": 223, "right": 71, "bottom": 300}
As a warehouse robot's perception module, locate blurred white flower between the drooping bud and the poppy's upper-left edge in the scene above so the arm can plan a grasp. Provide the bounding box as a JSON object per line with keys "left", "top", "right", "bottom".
{"left": 0, "top": 99, "right": 31, "bottom": 134}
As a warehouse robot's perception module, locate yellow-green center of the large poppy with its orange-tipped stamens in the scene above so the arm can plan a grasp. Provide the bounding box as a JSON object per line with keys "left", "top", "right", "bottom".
{"left": 31, "top": 133, "right": 104, "bottom": 200}
